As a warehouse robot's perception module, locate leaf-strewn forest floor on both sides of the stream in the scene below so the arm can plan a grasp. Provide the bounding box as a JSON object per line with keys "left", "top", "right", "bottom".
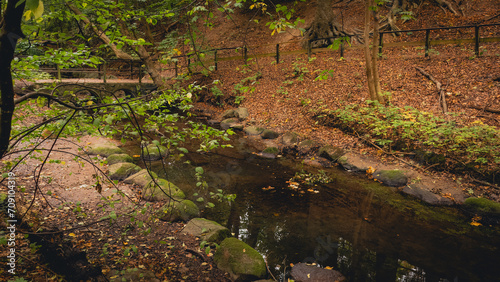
{"left": 0, "top": 0, "right": 500, "bottom": 281}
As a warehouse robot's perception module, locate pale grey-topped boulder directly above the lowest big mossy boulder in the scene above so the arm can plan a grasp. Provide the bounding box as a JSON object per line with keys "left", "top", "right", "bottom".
{"left": 182, "top": 218, "right": 231, "bottom": 244}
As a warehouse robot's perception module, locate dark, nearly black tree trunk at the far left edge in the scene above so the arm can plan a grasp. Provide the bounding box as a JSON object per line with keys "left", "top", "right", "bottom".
{"left": 0, "top": 1, "right": 25, "bottom": 158}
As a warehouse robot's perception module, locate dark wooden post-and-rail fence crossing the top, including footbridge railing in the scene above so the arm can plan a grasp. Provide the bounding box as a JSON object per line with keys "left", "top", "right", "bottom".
{"left": 35, "top": 23, "right": 500, "bottom": 83}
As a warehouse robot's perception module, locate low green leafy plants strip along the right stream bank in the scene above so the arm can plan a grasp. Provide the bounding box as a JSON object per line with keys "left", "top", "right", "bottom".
{"left": 327, "top": 101, "right": 500, "bottom": 172}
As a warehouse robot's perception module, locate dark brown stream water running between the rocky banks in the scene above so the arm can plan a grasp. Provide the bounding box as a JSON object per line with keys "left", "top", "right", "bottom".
{"left": 130, "top": 133, "right": 500, "bottom": 281}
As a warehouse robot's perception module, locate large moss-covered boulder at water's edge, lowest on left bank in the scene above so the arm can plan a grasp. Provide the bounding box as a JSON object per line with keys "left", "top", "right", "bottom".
{"left": 214, "top": 238, "right": 267, "bottom": 280}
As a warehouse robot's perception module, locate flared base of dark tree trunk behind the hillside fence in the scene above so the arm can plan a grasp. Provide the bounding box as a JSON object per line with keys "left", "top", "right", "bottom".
{"left": 303, "top": 0, "right": 360, "bottom": 47}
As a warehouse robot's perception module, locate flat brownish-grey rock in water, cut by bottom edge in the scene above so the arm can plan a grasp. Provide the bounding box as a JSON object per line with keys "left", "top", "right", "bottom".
{"left": 292, "top": 263, "right": 346, "bottom": 282}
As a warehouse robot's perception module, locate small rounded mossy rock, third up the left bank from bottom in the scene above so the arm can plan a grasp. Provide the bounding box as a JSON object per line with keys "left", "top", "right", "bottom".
{"left": 158, "top": 200, "right": 200, "bottom": 222}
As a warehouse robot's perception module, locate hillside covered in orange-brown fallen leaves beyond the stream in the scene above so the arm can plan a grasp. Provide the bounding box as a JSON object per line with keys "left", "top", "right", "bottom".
{"left": 185, "top": 1, "right": 500, "bottom": 201}
